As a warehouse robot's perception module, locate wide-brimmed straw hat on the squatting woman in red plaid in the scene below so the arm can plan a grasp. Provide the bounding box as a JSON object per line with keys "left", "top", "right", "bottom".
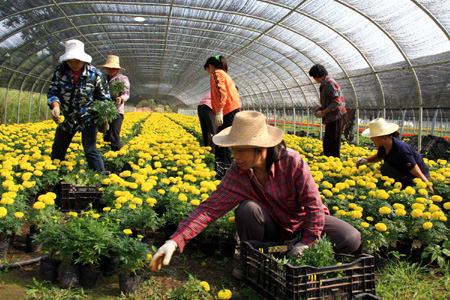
{"left": 213, "top": 111, "right": 284, "bottom": 148}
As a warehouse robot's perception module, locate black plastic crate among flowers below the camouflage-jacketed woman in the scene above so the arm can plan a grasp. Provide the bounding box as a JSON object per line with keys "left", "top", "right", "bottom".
{"left": 59, "top": 182, "right": 103, "bottom": 212}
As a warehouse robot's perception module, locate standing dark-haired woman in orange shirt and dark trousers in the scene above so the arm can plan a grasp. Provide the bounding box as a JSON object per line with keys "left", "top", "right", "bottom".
{"left": 204, "top": 55, "right": 241, "bottom": 169}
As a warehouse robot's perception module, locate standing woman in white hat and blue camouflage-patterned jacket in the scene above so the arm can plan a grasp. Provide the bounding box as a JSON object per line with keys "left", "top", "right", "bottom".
{"left": 47, "top": 40, "right": 111, "bottom": 172}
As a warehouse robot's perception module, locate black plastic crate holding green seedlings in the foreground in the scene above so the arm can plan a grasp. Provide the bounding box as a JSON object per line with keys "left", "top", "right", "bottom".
{"left": 241, "top": 241, "right": 375, "bottom": 300}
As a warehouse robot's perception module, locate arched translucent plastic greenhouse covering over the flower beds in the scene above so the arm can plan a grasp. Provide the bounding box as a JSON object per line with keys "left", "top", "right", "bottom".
{"left": 0, "top": 0, "right": 450, "bottom": 147}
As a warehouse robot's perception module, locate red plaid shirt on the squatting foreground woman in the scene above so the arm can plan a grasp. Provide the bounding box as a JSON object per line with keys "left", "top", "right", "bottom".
{"left": 170, "top": 148, "right": 330, "bottom": 251}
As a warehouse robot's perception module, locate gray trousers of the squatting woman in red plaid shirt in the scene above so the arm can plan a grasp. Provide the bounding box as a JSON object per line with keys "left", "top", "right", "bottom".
{"left": 234, "top": 200, "right": 361, "bottom": 254}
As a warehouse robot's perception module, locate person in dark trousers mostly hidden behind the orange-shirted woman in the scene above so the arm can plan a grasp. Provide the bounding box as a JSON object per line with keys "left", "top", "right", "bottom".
{"left": 197, "top": 91, "right": 217, "bottom": 154}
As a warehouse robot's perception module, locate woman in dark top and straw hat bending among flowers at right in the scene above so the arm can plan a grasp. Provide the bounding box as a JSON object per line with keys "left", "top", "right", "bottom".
{"left": 356, "top": 118, "right": 433, "bottom": 190}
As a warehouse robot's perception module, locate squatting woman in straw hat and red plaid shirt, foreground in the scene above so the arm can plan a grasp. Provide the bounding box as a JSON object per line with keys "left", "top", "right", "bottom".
{"left": 150, "top": 111, "right": 361, "bottom": 277}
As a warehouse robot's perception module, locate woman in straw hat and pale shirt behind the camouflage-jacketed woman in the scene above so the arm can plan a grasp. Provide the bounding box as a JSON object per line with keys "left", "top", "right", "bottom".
{"left": 100, "top": 55, "right": 130, "bottom": 151}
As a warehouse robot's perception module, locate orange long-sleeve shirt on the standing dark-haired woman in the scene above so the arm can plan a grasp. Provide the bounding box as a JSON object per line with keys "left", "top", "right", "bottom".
{"left": 210, "top": 69, "right": 241, "bottom": 115}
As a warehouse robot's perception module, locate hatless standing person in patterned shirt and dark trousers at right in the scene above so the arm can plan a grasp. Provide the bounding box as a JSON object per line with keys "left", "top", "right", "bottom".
{"left": 309, "top": 64, "right": 347, "bottom": 158}
